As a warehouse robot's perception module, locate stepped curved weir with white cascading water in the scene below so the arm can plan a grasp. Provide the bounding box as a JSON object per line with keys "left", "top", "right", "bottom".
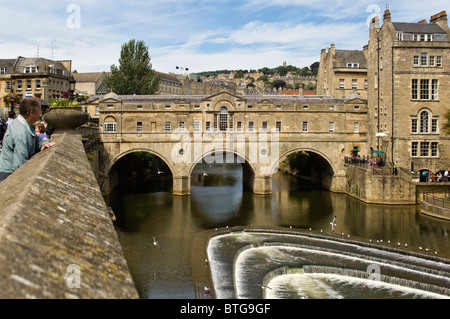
{"left": 207, "top": 229, "right": 450, "bottom": 298}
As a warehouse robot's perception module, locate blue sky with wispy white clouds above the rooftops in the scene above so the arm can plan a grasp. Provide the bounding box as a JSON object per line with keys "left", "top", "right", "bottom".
{"left": 0, "top": 0, "right": 450, "bottom": 74}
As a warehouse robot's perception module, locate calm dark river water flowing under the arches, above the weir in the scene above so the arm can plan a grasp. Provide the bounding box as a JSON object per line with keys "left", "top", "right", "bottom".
{"left": 108, "top": 164, "right": 450, "bottom": 299}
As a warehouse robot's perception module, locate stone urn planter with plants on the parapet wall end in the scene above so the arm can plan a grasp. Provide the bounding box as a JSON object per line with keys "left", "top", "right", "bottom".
{"left": 44, "top": 98, "right": 89, "bottom": 129}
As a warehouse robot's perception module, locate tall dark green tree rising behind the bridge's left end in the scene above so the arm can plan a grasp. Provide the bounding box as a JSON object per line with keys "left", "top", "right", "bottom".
{"left": 105, "top": 39, "right": 160, "bottom": 95}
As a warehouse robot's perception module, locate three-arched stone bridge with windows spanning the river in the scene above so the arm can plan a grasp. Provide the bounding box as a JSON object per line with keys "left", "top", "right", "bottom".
{"left": 89, "top": 92, "right": 369, "bottom": 195}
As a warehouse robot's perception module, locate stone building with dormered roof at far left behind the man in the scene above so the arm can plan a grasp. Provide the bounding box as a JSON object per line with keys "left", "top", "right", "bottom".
{"left": 0, "top": 56, "right": 72, "bottom": 107}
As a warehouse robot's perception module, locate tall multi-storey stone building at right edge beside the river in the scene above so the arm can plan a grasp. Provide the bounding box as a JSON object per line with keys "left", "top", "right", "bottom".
{"left": 364, "top": 10, "right": 450, "bottom": 173}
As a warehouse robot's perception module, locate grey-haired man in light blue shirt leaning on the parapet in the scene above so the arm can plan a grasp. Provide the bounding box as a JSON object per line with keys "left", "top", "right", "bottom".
{"left": 0, "top": 98, "right": 55, "bottom": 182}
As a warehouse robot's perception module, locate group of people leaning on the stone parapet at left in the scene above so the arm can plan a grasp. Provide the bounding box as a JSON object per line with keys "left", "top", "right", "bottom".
{"left": 0, "top": 98, "right": 55, "bottom": 182}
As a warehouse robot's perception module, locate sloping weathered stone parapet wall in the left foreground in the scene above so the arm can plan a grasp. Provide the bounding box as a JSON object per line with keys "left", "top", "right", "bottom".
{"left": 0, "top": 131, "right": 139, "bottom": 299}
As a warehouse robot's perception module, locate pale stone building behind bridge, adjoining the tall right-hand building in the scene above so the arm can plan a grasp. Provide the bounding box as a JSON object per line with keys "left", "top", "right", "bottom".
{"left": 317, "top": 44, "right": 367, "bottom": 99}
